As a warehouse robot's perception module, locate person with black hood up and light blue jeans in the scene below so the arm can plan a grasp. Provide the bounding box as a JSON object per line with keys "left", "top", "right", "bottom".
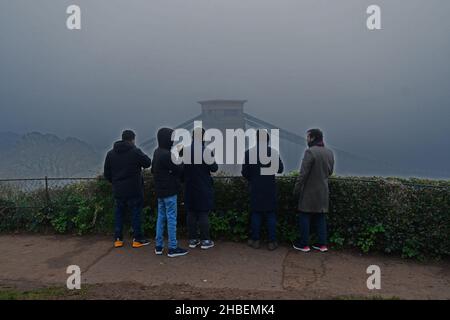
{"left": 152, "top": 128, "right": 188, "bottom": 257}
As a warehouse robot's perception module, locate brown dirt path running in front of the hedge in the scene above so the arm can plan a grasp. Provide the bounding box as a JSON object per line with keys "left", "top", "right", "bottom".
{"left": 0, "top": 235, "right": 450, "bottom": 299}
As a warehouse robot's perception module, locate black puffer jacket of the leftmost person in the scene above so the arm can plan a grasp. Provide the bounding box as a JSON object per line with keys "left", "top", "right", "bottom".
{"left": 103, "top": 141, "right": 152, "bottom": 199}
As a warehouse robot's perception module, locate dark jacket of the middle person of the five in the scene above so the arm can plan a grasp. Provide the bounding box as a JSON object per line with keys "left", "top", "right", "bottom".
{"left": 184, "top": 143, "right": 219, "bottom": 212}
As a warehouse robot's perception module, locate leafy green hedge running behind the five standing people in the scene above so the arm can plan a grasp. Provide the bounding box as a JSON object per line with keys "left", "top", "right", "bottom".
{"left": 0, "top": 172, "right": 450, "bottom": 258}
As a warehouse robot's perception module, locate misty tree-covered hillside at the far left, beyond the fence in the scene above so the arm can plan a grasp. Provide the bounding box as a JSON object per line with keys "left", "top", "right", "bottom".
{"left": 0, "top": 132, "right": 101, "bottom": 178}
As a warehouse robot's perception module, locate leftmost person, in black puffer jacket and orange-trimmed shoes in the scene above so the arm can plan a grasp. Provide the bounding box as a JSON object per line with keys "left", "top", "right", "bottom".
{"left": 103, "top": 130, "right": 152, "bottom": 248}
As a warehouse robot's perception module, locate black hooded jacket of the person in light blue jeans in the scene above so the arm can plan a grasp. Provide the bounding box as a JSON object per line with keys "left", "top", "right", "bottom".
{"left": 152, "top": 128, "right": 183, "bottom": 198}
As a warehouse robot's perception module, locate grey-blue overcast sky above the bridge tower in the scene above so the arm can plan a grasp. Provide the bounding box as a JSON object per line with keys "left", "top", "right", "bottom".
{"left": 0, "top": 0, "right": 450, "bottom": 173}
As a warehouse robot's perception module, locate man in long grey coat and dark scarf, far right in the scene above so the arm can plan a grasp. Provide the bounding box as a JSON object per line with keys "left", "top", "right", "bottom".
{"left": 294, "top": 129, "right": 334, "bottom": 252}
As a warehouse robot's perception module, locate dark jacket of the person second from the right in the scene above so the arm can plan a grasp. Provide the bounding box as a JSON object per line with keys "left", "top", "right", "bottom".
{"left": 242, "top": 147, "right": 284, "bottom": 212}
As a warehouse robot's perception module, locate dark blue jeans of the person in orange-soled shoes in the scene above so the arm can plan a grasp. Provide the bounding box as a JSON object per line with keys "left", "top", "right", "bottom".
{"left": 114, "top": 197, "right": 144, "bottom": 239}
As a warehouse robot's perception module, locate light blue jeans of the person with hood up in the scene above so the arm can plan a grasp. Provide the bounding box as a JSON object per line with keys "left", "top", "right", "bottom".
{"left": 155, "top": 195, "right": 178, "bottom": 249}
